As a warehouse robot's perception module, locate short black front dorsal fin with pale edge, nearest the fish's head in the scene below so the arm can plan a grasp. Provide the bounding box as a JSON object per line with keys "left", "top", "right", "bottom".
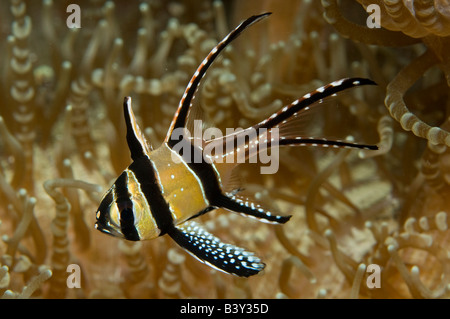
{"left": 123, "top": 96, "right": 152, "bottom": 161}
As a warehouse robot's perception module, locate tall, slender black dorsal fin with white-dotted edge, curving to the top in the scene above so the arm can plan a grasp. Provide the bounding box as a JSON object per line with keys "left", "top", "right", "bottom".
{"left": 164, "top": 12, "right": 271, "bottom": 147}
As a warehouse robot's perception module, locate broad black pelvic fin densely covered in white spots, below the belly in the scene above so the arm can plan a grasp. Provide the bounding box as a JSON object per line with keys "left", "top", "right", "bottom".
{"left": 168, "top": 221, "right": 265, "bottom": 277}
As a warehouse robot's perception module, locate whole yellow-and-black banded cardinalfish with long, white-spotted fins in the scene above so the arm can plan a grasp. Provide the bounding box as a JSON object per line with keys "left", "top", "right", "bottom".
{"left": 95, "top": 13, "right": 377, "bottom": 277}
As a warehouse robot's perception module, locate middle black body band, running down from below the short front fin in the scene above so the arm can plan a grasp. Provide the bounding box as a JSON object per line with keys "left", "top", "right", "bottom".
{"left": 128, "top": 156, "right": 173, "bottom": 236}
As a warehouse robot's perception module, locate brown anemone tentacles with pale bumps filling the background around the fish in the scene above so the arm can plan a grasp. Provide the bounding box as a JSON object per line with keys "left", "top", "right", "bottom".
{"left": 0, "top": 0, "right": 450, "bottom": 298}
